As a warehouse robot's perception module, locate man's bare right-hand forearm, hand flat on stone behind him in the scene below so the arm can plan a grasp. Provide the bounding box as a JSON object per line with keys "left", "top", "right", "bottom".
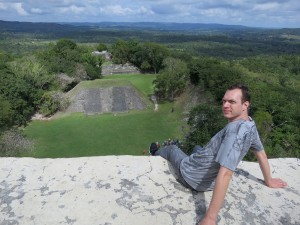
{"left": 254, "top": 150, "right": 287, "bottom": 188}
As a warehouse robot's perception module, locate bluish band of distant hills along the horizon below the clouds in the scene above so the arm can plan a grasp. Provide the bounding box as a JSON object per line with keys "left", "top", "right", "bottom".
{"left": 0, "top": 20, "right": 300, "bottom": 35}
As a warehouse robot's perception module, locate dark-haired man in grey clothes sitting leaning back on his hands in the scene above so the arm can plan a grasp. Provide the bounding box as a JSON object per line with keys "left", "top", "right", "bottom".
{"left": 150, "top": 85, "right": 287, "bottom": 225}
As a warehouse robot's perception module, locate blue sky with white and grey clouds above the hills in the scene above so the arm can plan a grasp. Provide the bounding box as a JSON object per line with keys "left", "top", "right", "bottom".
{"left": 0, "top": 0, "right": 300, "bottom": 28}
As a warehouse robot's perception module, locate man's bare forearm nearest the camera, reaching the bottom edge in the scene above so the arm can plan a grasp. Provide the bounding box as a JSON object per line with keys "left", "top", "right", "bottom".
{"left": 199, "top": 166, "right": 233, "bottom": 225}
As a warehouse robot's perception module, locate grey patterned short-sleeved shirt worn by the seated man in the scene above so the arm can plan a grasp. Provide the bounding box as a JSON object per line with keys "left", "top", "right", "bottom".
{"left": 180, "top": 120, "right": 263, "bottom": 191}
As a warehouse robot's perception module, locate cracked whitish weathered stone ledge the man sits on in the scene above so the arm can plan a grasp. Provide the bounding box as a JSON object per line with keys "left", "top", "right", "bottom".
{"left": 0, "top": 156, "right": 300, "bottom": 225}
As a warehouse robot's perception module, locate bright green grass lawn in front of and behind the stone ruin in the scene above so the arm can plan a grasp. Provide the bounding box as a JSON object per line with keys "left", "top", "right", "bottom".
{"left": 21, "top": 75, "right": 183, "bottom": 158}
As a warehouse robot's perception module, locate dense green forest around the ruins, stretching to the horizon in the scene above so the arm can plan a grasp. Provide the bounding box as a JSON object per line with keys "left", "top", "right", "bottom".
{"left": 0, "top": 21, "right": 300, "bottom": 160}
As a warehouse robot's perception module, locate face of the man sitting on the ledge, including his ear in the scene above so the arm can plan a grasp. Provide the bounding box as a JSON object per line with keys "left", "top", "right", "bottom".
{"left": 222, "top": 89, "right": 249, "bottom": 122}
